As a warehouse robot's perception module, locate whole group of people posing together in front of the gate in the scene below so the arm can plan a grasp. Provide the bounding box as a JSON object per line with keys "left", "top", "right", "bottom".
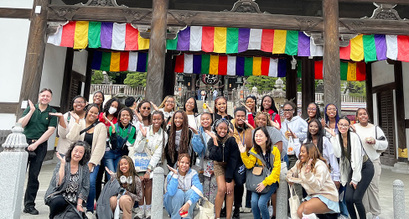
{"left": 19, "top": 89, "right": 388, "bottom": 219}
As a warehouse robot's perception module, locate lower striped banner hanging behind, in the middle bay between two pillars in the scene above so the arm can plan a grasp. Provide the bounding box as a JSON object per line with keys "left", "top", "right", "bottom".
{"left": 175, "top": 53, "right": 287, "bottom": 77}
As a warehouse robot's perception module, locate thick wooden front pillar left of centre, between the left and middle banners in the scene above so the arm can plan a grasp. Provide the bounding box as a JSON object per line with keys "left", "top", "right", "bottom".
{"left": 145, "top": 0, "right": 169, "bottom": 104}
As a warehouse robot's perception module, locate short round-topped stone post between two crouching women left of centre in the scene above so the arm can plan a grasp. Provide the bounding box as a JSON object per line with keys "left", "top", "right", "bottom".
{"left": 151, "top": 167, "right": 165, "bottom": 219}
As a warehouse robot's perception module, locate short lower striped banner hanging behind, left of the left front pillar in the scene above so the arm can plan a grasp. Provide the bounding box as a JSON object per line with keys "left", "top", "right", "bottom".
{"left": 91, "top": 50, "right": 148, "bottom": 72}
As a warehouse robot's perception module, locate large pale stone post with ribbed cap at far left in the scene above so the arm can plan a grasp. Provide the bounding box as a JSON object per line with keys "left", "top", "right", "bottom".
{"left": 0, "top": 123, "right": 28, "bottom": 219}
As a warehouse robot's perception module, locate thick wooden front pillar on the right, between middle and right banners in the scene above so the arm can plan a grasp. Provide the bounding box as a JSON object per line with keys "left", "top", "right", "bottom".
{"left": 322, "top": 0, "right": 341, "bottom": 109}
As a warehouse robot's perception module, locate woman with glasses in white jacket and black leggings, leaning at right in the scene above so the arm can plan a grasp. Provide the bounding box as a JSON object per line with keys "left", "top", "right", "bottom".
{"left": 330, "top": 117, "right": 374, "bottom": 219}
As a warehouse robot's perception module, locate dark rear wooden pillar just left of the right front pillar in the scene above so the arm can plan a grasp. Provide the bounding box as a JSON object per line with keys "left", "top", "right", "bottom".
{"left": 301, "top": 57, "right": 315, "bottom": 118}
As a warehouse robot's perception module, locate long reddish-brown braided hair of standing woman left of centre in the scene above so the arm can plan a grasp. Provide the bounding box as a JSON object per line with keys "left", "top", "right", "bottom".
{"left": 163, "top": 110, "right": 189, "bottom": 162}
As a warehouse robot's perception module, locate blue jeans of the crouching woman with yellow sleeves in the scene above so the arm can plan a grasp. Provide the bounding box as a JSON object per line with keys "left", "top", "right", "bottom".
{"left": 251, "top": 183, "right": 278, "bottom": 219}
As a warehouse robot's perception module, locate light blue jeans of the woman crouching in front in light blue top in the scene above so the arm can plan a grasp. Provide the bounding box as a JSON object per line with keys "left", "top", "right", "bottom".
{"left": 163, "top": 189, "right": 196, "bottom": 219}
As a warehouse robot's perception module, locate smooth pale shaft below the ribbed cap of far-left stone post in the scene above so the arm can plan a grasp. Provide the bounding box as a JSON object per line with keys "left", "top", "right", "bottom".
{"left": 0, "top": 151, "right": 28, "bottom": 219}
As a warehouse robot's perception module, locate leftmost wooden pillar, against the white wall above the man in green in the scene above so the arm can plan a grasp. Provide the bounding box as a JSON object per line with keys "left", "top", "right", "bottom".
{"left": 16, "top": 0, "right": 48, "bottom": 116}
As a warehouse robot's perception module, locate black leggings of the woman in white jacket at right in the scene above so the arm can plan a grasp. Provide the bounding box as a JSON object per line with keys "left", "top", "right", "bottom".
{"left": 345, "top": 159, "right": 374, "bottom": 219}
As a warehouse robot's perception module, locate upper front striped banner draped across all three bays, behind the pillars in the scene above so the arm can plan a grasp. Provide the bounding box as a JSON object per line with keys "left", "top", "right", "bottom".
{"left": 48, "top": 21, "right": 409, "bottom": 62}
